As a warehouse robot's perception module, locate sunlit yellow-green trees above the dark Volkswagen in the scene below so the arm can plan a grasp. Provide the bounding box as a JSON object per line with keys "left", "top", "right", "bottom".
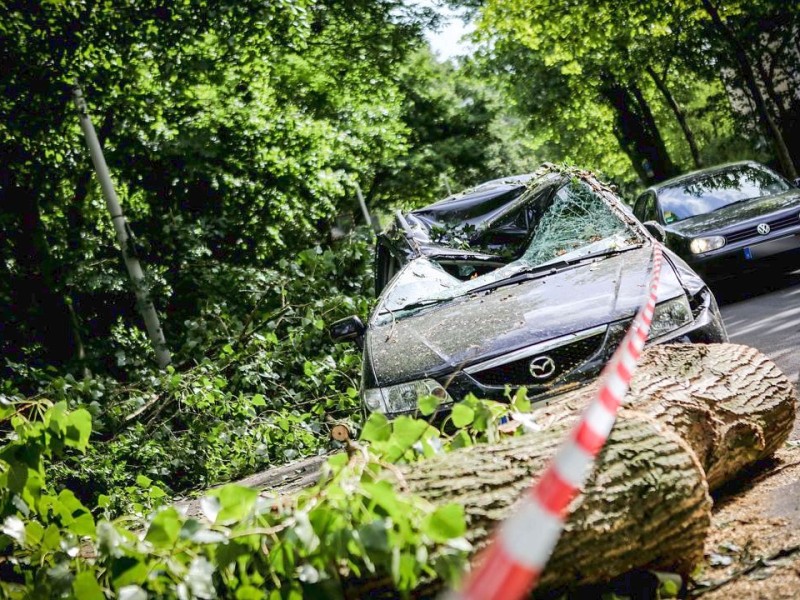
{"left": 450, "top": 0, "right": 800, "bottom": 187}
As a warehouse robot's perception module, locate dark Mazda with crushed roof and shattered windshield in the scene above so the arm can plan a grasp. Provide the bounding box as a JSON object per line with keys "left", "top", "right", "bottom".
{"left": 331, "top": 168, "right": 727, "bottom": 417}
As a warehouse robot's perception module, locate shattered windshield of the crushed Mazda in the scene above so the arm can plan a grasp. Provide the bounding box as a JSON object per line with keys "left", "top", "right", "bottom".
{"left": 373, "top": 179, "right": 646, "bottom": 325}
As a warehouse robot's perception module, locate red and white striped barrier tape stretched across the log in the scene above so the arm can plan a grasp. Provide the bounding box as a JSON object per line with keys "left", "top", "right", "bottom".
{"left": 446, "top": 244, "right": 662, "bottom": 600}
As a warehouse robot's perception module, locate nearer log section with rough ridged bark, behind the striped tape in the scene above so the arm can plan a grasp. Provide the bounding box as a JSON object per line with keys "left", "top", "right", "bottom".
{"left": 403, "top": 410, "right": 711, "bottom": 588}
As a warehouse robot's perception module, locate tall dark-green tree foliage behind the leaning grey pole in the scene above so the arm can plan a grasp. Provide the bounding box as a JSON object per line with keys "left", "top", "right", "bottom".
{"left": 0, "top": 0, "right": 424, "bottom": 371}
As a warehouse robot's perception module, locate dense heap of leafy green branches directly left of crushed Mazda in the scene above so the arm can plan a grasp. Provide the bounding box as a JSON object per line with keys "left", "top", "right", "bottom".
{"left": 20, "top": 233, "right": 371, "bottom": 513}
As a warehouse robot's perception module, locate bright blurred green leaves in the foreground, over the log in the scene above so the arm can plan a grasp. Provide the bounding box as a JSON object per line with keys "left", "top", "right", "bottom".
{"left": 0, "top": 380, "right": 530, "bottom": 599}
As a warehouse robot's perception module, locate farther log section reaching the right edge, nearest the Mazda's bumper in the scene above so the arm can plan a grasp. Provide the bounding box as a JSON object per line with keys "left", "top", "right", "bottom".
{"left": 536, "top": 344, "right": 796, "bottom": 490}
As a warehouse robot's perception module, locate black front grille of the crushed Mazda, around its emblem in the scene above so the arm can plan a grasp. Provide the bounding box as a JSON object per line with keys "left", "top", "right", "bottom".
{"left": 471, "top": 331, "right": 605, "bottom": 386}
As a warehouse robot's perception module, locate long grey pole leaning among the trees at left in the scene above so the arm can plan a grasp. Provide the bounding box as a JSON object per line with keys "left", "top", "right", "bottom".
{"left": 72, "top": 84, "right": 172, "bottom": 369}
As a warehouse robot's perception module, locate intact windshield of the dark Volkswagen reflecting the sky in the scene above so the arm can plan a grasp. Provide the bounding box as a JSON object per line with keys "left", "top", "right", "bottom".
{"left": 643, "top": 165, "right": 790, "bottom": 223}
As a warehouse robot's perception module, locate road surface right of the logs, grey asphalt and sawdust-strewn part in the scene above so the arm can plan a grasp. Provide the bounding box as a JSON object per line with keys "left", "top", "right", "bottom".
{"left": 700, "top": 271, "right": 800, "bottom": 600}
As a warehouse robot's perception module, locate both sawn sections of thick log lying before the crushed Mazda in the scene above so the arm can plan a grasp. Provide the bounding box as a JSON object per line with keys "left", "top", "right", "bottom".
{"left": 231, "top": 344, "right": 796, "bottom": 598}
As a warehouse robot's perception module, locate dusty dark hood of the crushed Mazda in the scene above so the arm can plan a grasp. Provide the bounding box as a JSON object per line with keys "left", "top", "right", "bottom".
{"left": 365, "top": 247, "right": 683, "bottom": 386}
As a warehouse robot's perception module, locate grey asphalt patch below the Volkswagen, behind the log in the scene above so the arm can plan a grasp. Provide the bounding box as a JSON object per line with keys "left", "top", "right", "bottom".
{"left": 714, "top": 271, "right": 800, "bottom": 386}
